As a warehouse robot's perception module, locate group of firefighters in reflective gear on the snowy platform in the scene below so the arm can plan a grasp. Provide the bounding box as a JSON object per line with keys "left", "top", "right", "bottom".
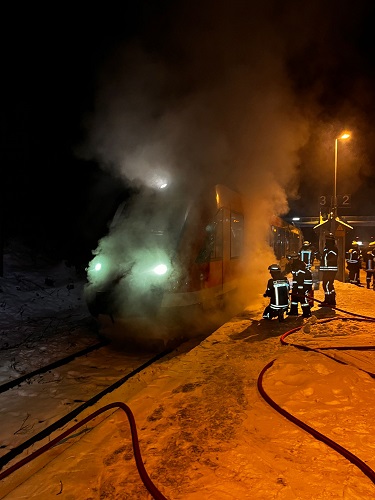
{"left": 263, "top": 233, "right": 375, "bottom": 321}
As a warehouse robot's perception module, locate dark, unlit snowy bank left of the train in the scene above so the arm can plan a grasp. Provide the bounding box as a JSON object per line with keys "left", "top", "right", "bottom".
{"left": 0, "top": 244, "right": 90, "bottom": 350}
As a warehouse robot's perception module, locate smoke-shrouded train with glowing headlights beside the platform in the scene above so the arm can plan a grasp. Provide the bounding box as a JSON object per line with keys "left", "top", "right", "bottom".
{"left": 84, "top": 184, "right": 303, "bottom": 346}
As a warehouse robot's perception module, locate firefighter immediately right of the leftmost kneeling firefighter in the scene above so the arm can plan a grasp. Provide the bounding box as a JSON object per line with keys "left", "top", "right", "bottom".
{"left": 284, "top": 254, "right": 312, "bottom": 318}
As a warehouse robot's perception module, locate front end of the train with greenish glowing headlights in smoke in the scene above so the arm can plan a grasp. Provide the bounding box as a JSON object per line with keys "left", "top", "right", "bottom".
{"left": 85, "top": 188, "right": 194, "bottom": 348}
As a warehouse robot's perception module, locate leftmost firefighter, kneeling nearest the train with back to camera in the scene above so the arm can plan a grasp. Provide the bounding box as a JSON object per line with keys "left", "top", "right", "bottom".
{"left": 263, "top": 264, "right": 290, "bottom": 321}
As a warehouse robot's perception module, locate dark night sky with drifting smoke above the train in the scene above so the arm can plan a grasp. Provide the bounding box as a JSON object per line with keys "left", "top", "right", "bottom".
{"left": 1, "top": 0, "right": 375, "bottom": 261}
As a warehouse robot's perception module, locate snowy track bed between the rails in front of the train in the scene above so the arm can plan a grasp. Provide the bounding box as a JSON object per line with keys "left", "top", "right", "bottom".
{"left": 0, "top": 341, "right": 175, "bottom": 470}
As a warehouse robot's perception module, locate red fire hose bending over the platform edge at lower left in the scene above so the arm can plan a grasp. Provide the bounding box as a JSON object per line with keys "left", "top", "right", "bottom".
{"left": 0, "top": 402, "right": 167, "bottom": 500}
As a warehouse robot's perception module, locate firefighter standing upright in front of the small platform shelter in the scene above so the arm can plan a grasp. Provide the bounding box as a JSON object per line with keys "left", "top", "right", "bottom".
{"left": 319, "top": 233, "right": 339, "bottom": 307}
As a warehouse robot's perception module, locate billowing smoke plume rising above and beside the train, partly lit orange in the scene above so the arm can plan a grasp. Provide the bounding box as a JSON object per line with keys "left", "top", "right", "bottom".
{"left": 80, "top": 0, "right": 324, "bottom": 340}
